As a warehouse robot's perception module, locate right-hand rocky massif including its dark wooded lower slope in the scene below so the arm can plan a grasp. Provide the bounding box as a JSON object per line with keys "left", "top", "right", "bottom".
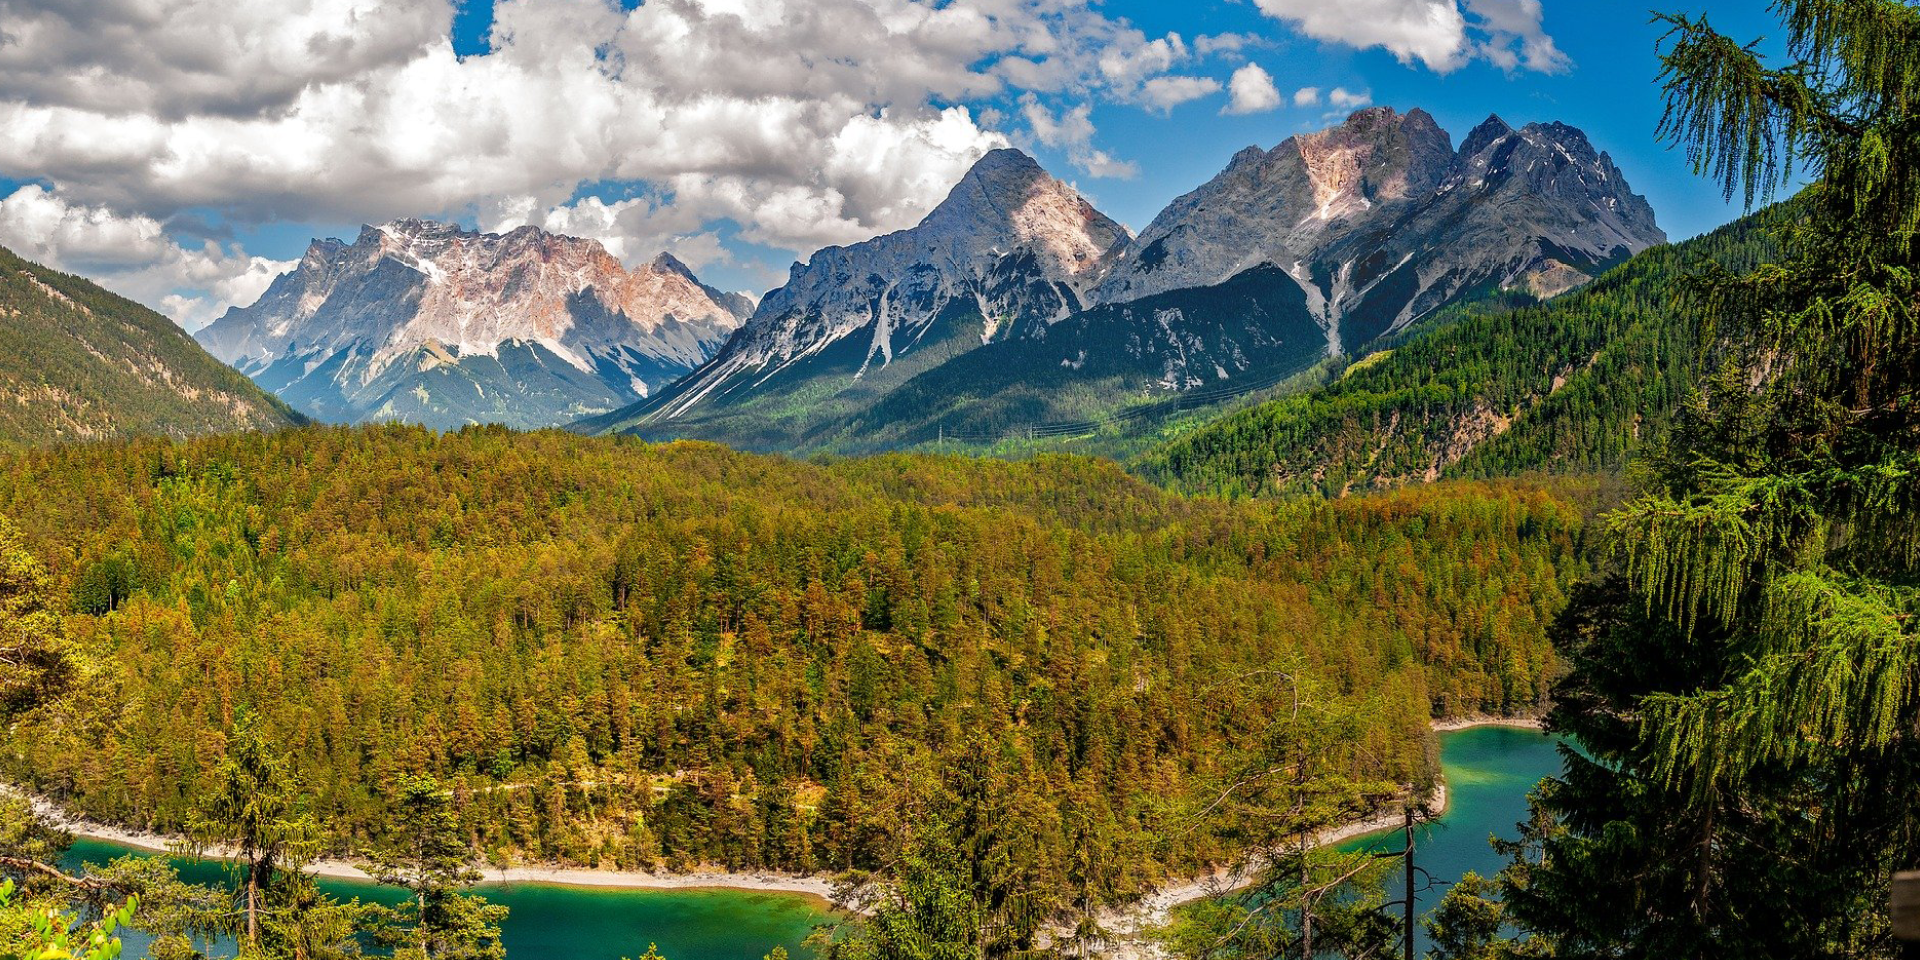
{"left": 779, "top": 108, "right": 1665, "bottom": 451}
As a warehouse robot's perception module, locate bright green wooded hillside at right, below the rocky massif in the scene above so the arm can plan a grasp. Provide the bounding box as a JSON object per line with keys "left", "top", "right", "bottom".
{"left": 1140, "top": 207, "right": 1791, "bottom": 495}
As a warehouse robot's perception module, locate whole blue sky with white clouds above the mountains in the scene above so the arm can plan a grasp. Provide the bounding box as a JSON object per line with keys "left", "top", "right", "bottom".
{"left": 0, "top": 0, "right": 1778, "bottom": 330}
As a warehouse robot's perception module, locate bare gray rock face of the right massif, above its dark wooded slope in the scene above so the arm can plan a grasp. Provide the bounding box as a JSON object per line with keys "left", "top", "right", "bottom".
{"left": 1094, "top": 108, "right": 1667, "bottom": 353}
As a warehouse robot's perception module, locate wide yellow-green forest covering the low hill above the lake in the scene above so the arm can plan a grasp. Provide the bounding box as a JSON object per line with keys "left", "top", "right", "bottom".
{"left": 0, "top": 426, "right": 1596, "bottom": 891}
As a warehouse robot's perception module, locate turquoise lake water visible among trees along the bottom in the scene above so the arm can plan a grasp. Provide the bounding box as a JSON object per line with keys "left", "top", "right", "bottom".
{"left": 67, "top": 726, "right": 1559, "bottom": 960}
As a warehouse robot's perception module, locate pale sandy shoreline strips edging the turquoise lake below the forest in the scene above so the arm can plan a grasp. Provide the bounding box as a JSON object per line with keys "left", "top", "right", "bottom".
{"left": 0, "top": 716, "right": 1540, "bottom": 929}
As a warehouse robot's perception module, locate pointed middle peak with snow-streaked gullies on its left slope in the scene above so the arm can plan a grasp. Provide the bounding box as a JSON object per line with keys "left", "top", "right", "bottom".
{"left": 580, "top": 150, "right": 1129, "bottom": 447}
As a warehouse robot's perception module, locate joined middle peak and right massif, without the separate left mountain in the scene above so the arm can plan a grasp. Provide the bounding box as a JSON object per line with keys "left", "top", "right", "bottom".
{"left": 580, "top": 108, "right": 1667, "bottom": 451}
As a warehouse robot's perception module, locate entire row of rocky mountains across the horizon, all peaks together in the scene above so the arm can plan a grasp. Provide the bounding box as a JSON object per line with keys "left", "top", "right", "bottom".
{"left": 176, "top": 108, "right": 1665, "bottom": 451}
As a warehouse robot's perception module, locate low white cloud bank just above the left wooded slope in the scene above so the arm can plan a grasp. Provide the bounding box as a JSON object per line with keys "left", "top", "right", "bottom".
{"left": 0, "top": 184, "right": 294, "bottom": 330}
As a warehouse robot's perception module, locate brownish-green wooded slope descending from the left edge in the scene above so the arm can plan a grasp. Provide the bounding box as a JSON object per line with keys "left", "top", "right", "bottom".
{"left": 0, "top": 248, "right": 301, "bottom": 444}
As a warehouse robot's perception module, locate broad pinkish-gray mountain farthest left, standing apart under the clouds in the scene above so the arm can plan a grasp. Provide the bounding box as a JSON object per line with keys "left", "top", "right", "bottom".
{"left": 200, "top": 221, "right": 747, "bottom": 428}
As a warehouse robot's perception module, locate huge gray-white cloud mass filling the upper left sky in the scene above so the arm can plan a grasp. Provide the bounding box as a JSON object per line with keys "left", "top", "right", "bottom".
{"left": 0, "top": 0, "right": 1252, "bottom": 305}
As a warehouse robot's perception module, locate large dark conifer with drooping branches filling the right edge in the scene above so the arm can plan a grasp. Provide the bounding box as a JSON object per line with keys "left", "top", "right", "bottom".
{"left": 1505, "top": 0, "right": 1920, "bottom": 956}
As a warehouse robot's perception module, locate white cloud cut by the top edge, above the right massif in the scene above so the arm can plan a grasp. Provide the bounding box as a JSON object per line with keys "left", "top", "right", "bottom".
{"left": 1254, "top": 0, "right": 1569, "bottom": 73}
